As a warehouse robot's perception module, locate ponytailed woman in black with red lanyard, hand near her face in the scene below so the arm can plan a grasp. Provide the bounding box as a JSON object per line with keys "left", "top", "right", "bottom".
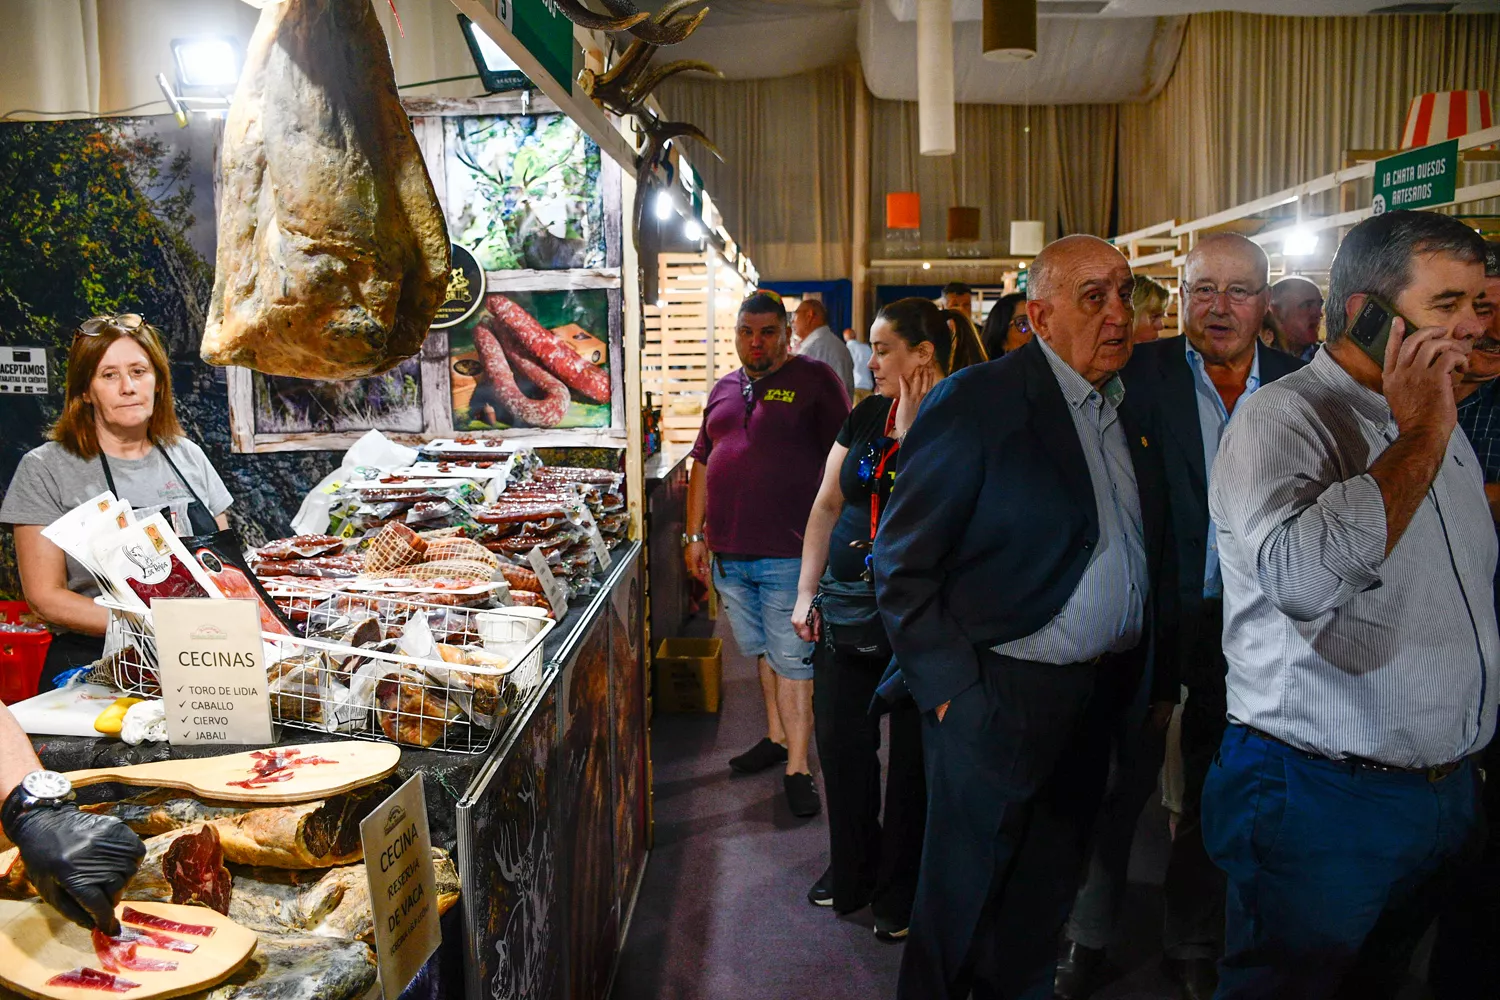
{"left": 792, "top": 298, "right": 984, "bottom": 940}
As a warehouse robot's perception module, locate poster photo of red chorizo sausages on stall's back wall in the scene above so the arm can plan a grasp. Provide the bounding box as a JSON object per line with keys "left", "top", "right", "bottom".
{"left": 449, "top": 289, "right": 614, "bottom": 430}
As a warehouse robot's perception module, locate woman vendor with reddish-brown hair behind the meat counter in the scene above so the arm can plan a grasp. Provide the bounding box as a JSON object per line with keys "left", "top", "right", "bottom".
{"left": 0, "top": 313, "right": 231, "bottom": 691}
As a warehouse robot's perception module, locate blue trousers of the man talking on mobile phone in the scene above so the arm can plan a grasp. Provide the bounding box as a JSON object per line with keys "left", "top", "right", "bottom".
{"left": 1203, "top": 726, "right": 1484, "bottom": 1000}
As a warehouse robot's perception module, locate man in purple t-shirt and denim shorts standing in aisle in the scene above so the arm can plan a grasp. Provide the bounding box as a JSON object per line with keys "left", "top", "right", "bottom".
{"left": 683, "top": 291, "right": 849, "bottom": 816}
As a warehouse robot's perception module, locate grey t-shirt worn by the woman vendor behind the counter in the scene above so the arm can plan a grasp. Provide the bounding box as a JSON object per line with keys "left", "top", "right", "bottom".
{"left": 0, "top": 438, "right": 234, "bottom": 597}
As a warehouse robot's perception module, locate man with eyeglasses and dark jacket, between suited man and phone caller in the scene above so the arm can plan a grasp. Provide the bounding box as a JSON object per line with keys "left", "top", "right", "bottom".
{"left": 1056, "top": 232, "right": 1302, "bottom": 1000}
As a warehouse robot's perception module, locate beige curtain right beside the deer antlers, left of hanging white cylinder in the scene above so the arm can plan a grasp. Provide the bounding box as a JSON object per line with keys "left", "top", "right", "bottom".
{"left": 656, "top": 66, "right": 864, "bottom": 279}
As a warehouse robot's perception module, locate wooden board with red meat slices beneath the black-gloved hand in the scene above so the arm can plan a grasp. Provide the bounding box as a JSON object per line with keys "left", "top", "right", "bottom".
{"left": 0, "top": 900, "right": 255, "bottom": 1000}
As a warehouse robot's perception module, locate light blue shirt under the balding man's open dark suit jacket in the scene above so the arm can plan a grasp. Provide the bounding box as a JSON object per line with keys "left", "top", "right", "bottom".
{"left": 995, "top": 340, "right": 1149, "bottom": 663}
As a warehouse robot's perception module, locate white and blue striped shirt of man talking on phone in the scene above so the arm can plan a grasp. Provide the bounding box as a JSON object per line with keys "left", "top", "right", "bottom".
{"left": 1209, "top": 351, "right": 1500, "bottom": 768}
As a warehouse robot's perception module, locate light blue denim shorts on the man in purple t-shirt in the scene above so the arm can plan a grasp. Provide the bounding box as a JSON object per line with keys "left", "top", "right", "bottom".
{"left": 714, "top": 559, "right": 813, "bottom": 681}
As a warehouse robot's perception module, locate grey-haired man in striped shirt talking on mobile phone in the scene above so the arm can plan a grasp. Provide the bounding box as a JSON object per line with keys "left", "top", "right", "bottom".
{"left": 1203, "top": 211, "right": 1500, "bottom": 1000}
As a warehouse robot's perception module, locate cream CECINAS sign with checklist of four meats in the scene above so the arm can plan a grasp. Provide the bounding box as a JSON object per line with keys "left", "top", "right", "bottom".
{"left": 152, "top": 598, "right": 272, "bottom": 747}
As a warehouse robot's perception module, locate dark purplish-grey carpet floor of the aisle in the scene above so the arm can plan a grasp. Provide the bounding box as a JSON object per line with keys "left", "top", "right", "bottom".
{"left": 612, "top": 618, "right": 1194, "bottom": 1000}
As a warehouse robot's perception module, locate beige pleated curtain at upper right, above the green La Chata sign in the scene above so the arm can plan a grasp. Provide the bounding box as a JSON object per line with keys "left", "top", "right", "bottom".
{"left": 1119, "top": 13, "right": 1500, "bottom": 231}
